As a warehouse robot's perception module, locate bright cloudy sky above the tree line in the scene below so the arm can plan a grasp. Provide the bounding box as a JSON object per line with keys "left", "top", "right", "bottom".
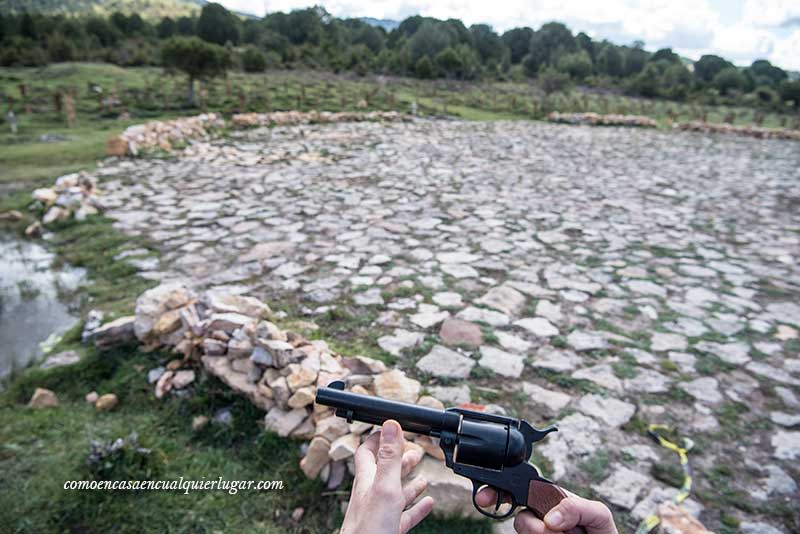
{"left": 217, "top": 0, "right": 800, "bottom": 70}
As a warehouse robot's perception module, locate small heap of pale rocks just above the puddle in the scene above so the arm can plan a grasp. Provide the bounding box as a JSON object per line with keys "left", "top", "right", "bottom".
{"left": 25, "top": 172, "right": 103, "bottom": 236}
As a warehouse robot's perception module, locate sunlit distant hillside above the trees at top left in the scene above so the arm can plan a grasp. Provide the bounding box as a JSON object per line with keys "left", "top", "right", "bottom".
{"left": 0, "top": 0, "right": 206, "bottom": 19}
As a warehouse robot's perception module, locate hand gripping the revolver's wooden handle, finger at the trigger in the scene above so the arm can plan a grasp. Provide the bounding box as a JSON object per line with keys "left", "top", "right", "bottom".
{"left": 475, "top": 488, "right": 618, "bottom": 534}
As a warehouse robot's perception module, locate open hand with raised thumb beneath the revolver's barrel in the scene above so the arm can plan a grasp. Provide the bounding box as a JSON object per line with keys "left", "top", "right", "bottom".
{"left": 340, "top": 420, "right": 433, "bottom": 534}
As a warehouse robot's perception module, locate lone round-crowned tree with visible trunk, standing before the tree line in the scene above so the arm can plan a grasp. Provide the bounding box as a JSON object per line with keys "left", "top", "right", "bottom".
{"left": 161, "top": 37, "right": 231, "bottom": 106}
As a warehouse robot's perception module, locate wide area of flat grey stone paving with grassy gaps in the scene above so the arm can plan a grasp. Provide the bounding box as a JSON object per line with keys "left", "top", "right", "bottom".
{"left": 99, "top": 120, "right": 800, "bottom": 532}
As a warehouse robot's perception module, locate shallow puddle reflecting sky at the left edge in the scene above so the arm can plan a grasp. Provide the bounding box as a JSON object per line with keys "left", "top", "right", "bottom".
{"left": 0, "top": 233, "right": 85, "bottom": 380}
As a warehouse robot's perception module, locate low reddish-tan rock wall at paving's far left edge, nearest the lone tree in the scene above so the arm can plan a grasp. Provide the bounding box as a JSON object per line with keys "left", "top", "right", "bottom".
{"left": 106, "top": 113, "right": 225, "bottom": 156}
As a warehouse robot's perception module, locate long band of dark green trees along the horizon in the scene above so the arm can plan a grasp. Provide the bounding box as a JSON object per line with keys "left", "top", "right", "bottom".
{"left": 0, "top": 3, "right": 800, "bottom": 110}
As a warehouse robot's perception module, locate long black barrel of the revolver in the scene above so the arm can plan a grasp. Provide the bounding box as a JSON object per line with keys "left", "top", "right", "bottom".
{"left": 316, "top": 387, "right": 461, "bottom": 437}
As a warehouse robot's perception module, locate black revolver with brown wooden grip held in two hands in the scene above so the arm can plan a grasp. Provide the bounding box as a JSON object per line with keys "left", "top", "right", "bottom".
{"left": 316, "top": 380, "right": 586, "bottom": 534}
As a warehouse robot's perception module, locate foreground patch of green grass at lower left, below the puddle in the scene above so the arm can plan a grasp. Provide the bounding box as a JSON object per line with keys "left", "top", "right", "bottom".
{"left": 0, "top": 348, "right": 341, "bottom": 532}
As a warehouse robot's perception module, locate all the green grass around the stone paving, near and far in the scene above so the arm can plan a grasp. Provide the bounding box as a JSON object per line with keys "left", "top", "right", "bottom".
{"left": 0, "top": 64, "right": 796, "bottom": 532}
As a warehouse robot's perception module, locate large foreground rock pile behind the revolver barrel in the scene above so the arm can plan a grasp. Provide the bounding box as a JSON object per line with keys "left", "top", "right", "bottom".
{"left": 134, "top": 283, "right": 471, "bottom": 513}
